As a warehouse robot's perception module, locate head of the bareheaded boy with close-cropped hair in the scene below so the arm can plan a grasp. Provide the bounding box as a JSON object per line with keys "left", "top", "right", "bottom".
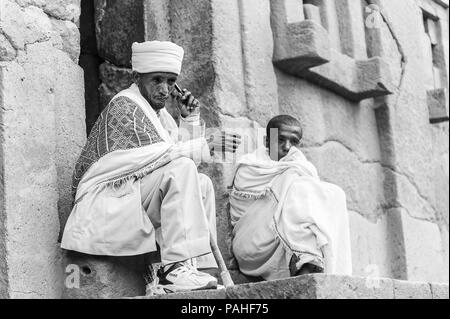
{"left": 266, "top": 115, "right": 303, "bottom": 161}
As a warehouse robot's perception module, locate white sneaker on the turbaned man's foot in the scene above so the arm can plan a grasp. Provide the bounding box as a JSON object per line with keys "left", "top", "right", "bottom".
{"left": 158, "top": 262, "right": 217, "bottom": 293}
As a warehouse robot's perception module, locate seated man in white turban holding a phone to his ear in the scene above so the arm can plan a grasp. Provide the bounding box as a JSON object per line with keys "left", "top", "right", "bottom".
{"left": 61, "top": 41, "right": 243, "bottom": 292}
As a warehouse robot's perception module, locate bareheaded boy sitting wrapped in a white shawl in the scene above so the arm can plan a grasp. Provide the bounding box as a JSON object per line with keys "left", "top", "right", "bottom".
{"left": 230, "top": 115, "right": 351, "bottom": 280}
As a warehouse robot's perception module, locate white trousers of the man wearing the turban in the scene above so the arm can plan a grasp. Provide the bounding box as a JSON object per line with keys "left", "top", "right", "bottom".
{"left": 140, "top": 157, "right": 217, "bottom": 268}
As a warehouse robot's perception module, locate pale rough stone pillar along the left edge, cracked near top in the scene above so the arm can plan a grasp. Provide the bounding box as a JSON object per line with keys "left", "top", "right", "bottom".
{"left": 0, "top": 0, "right": 85, "bottom": 298}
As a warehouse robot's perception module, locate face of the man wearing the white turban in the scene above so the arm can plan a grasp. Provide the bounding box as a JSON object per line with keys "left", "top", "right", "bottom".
{"left": 135, "top": 72, "right": 178, "bottom": 111}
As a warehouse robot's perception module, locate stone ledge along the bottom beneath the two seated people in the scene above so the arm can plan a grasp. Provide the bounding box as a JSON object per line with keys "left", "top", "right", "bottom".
{"left": 127, "top": 274, "right": 449, "bottom": 299}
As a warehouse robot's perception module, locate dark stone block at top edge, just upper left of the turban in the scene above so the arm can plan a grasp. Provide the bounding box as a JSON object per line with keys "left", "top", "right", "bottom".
{"left": 95, "top": 0, "right": 145, "bottom": 67}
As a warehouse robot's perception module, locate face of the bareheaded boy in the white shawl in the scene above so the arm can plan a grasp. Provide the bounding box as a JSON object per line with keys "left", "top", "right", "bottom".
{"left": 266, "top": 124, "right": 302, "bottom": 161}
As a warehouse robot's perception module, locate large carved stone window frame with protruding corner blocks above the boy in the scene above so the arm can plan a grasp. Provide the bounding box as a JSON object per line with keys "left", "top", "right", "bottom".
{"left": 271, "top": 0, "right": 393, "bottom": 102}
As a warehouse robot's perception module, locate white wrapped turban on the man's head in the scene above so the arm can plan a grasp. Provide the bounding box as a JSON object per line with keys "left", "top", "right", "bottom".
{"left": 131, "top": 41, "right": 184, "bottom": 75}
